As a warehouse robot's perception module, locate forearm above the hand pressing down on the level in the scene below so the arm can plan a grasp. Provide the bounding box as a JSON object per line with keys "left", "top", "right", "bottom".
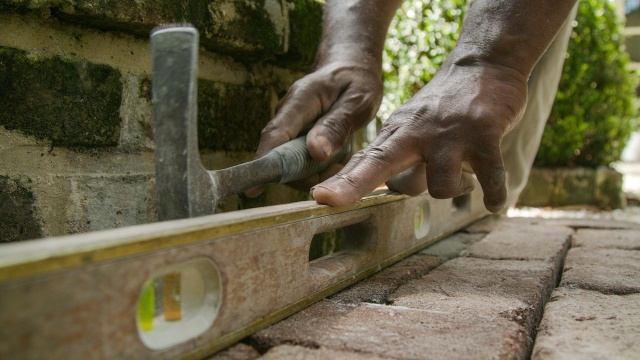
{"left": 452, "top": 0, "right": 576, "bottom": 78}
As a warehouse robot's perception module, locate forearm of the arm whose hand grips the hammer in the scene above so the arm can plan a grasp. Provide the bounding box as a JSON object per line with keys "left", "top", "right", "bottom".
{"left": 316, "top": 0, "right": 402, "bottom": 67}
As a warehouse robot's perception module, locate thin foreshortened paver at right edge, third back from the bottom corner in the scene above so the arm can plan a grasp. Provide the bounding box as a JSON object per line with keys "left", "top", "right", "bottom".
{"left": 572, "top": 229, "right": 640, "bottom": 250}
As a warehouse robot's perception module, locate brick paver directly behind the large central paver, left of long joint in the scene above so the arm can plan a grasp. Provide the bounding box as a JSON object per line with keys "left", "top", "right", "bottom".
{"left": 464, "top": 224, "right": 573, "bottom": 262}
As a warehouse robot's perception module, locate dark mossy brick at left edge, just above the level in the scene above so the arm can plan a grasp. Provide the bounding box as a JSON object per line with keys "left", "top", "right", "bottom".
{"left": 0, "top": 176, "right": 42, "bottom": 242}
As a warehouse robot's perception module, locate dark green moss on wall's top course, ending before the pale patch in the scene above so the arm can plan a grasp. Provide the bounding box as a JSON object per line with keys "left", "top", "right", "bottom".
{"left": 0, "top": 0, "right": 284, "bottom": 61}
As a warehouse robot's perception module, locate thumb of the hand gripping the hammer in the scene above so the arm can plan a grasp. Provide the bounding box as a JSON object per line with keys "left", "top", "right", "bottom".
{"left": 307, "top": 89, "right": 379, "bottom": 161}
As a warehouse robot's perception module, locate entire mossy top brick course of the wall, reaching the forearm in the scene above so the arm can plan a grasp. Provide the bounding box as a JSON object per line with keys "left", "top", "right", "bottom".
{"left": 0, "top": 0, "right": 322, "bottom": 64}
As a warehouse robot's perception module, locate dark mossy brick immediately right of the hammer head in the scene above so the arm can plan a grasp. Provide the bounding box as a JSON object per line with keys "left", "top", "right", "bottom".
{"left": 198, "top": 80, "right": 271, "bottom": 152}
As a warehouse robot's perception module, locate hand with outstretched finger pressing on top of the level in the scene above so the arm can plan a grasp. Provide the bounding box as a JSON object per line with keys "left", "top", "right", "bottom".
{"left": 312, "top": 53, "right": 527, "bottom": 212}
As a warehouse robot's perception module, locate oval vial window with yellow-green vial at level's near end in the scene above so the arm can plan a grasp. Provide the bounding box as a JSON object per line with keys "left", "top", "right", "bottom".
{"left": 136, "top": 258, "right": 222, "bottom": 350}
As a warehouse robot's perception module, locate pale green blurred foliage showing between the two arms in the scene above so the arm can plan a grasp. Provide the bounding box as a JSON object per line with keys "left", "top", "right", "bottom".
{"left": 378, "top": 0, "right": 466, "bottom": 119}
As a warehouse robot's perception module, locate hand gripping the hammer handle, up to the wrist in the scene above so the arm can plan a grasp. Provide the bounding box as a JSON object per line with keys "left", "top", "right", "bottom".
{"left": 245, "top": 57, "right": 382, "bottom": 197}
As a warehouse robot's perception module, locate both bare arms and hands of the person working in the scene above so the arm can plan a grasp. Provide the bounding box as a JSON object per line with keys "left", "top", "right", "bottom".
{"left": 248, "top": 0, "right": 575, "bottom": 212}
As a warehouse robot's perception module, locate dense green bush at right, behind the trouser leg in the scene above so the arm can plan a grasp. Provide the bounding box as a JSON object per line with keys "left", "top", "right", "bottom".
{"left": 536, "top": 0, "right": 637, "bottom": 167}
